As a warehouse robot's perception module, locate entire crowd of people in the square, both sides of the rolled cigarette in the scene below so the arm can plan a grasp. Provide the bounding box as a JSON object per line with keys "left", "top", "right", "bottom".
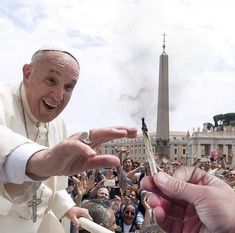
{"left": 67, "top": 152, "right": 235, "bottom": 233}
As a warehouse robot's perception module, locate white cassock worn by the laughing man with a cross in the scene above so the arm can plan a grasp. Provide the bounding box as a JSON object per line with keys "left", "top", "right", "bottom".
{"left": 0, "top": 85, "right": 75, "bottom": 233}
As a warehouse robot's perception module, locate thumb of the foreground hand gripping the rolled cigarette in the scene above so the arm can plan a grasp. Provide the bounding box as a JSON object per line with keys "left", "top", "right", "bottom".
{"left": 154, "top": 172, "right": 205, "bottom": 203}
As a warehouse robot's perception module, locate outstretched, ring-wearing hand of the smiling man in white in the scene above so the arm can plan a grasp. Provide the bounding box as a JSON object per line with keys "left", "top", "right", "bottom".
{"left": 26, "top": 127, "right": 137, "bottom": 178}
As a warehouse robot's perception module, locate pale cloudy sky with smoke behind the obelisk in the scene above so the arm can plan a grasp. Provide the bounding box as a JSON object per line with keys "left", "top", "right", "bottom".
{"left": 0, "top": 0, "right": 235, "bottom": 133}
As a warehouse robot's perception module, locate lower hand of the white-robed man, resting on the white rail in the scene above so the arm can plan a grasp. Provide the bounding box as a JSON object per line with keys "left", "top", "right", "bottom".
{"left": 64, "top": 206, "right": 92, "bottom": 228}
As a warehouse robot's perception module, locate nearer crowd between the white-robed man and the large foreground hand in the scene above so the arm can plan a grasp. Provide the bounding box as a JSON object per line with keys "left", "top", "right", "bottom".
{"left": 67, "top": 157, "right": 160, "bottom": 233}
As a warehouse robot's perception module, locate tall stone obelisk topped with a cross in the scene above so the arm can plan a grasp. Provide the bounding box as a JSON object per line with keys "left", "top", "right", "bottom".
{"left": 156, "top": 33, "right": 170, "bottom": 159}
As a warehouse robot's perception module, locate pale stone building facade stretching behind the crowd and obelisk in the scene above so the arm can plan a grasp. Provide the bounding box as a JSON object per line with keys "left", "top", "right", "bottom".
{"left": 99, "top": 126, "right": 235, "bottom": 168}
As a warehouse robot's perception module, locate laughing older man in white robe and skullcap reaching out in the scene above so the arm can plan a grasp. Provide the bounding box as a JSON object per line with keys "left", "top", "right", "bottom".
{"left": 0, "top": 48, "right": 136, "bottom": 233}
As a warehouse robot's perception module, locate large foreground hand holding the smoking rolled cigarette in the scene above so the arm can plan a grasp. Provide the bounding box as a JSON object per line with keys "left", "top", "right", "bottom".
{"left": 141, "top": 166, "right": 235, "bottom": 233}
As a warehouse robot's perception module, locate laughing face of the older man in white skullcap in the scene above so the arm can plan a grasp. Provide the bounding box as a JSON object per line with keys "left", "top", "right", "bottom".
{"left": 23, "top": 51, "right": 79, "bottom": 122}
